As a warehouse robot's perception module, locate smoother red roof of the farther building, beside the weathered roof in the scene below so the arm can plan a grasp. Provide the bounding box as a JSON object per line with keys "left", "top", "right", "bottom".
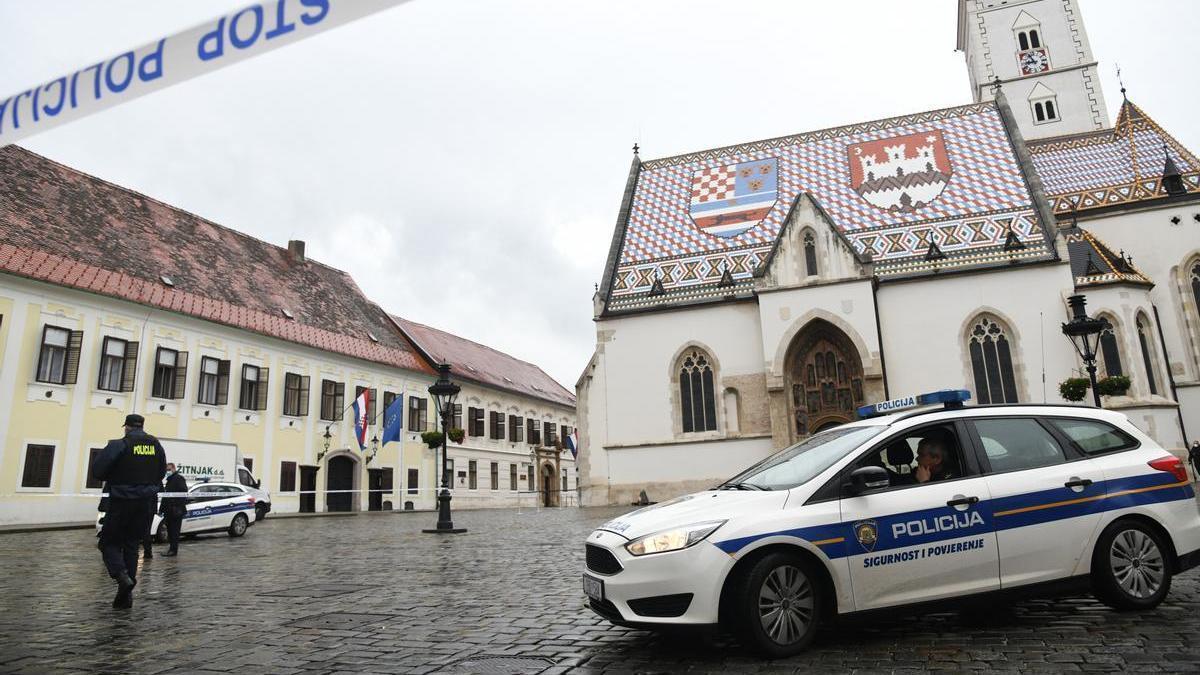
{"left": 392, "top": 315, "right": 575, "bottom": 408}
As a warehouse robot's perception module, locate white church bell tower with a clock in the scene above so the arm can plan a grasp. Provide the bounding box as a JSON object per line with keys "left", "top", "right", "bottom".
{"left": 958, "top": 0, "right": 1110, "bottom": 141}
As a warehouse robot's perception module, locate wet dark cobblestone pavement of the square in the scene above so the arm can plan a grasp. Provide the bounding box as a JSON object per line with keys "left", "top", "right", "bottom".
{"left": 0, "top": 509, "right": 1200, "bottom": 674}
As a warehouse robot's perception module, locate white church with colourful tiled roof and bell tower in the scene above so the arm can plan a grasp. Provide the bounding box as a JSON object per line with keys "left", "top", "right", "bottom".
{"left": 576, "top": 0, "right": 1200, "bottom": 504}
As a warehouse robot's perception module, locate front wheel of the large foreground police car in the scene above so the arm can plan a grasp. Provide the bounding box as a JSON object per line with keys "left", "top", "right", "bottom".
{"left": 733, "top": 551, "right": 823, "bottom": 657}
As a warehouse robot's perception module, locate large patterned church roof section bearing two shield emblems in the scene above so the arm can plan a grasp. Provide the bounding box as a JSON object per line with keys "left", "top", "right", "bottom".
{"left": 605, "top": 103, "right": 1052, "bottom": 311}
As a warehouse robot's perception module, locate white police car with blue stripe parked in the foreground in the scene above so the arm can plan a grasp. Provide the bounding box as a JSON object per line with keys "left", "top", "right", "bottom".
{"left": 583, "top": 390, "right": 1200, "bottom": 657}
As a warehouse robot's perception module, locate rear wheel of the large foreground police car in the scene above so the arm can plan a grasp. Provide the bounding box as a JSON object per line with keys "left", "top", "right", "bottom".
{"left": 1092, "top": 520, "right": 1171, "bottom": 610}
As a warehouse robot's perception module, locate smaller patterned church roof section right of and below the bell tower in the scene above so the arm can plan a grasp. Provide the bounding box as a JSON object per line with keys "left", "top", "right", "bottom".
{"left": 1027, "top": 100, "right": 1200, "bottom": 214}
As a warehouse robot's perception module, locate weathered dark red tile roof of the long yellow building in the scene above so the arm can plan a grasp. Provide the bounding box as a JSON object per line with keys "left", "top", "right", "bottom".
{"left": 0, "top": 145, "right": 433, "bottom": 374}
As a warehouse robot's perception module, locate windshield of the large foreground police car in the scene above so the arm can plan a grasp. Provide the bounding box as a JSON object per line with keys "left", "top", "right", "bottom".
{"left": 720, "top": 426, "right": 884, "bottom": 490}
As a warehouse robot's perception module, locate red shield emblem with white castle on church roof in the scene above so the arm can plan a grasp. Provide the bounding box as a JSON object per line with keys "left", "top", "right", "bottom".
{"left": 848, "top": 129, "right": 953, "bottom": 213}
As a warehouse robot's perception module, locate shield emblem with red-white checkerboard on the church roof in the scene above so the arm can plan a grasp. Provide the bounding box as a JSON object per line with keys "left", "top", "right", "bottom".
{"left": 688, "top": 157, "right": 779, "bottom": 238}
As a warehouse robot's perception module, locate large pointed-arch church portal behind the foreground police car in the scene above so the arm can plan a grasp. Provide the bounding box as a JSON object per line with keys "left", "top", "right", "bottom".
{"left": 787, "top": 319, "right": 863, "bottom": 438}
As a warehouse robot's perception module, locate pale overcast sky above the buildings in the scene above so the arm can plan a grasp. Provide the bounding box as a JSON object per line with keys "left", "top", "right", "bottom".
{"left": 0, "top": 0, "right": 1200, "bottom": 389}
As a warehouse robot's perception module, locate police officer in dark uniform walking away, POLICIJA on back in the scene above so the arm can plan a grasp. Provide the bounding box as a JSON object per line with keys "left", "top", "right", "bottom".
{"left": 91, "top": 414, "right": 167, "bottom": 608}
